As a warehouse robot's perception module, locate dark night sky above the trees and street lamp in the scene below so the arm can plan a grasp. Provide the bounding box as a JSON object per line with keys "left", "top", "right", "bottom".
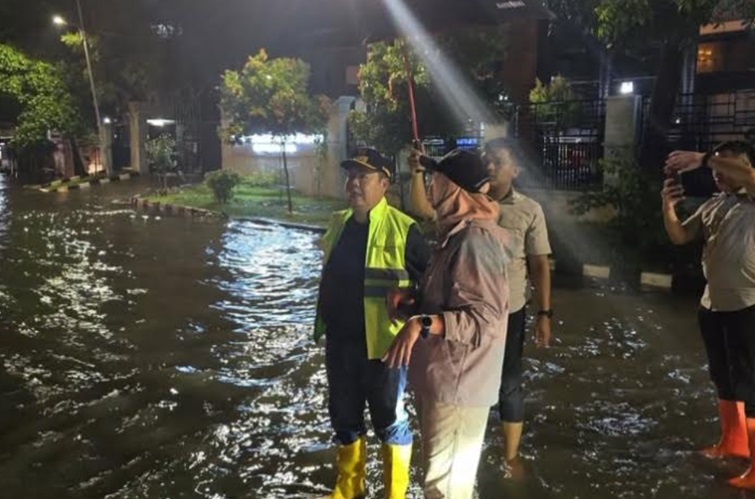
{"left": 0, "top": 0, "right": 552, "bottom": 96}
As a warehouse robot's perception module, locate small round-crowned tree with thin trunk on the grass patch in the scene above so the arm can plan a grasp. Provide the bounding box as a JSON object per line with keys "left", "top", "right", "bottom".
{"left": 220, "top": 50, "right": 329, "bottom": 213}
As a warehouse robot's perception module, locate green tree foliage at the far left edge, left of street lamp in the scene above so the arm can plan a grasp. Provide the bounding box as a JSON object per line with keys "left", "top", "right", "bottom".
{"left": 0, "top": 44, "right": 79, "bottom": 148}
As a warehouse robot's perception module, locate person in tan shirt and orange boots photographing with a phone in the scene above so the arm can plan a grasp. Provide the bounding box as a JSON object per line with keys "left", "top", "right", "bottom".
{"left": 661, "top": 142, "right": 755, "bottom": 490}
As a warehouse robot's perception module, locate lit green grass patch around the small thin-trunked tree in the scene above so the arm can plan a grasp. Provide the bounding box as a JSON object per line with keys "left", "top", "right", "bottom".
{"left": 144, "top": 183, "right": 346, "bottom": 227}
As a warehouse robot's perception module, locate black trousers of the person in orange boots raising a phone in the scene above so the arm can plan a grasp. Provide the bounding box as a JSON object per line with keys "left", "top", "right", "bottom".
{"left": 698, "top": 306, "right": 755, "bottom": 418}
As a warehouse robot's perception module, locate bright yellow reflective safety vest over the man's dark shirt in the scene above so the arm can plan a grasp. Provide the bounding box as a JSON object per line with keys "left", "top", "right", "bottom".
{"left": 314, "top": 198, "right": 416, "bottom": 359}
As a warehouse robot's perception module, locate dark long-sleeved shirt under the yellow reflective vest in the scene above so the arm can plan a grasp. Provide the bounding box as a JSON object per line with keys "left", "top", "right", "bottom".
{"left": 320, "top": 217, "right": 430, "bottom": 345}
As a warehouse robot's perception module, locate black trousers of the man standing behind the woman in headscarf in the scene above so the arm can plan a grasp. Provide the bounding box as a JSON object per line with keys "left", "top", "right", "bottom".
{"left": 498, "top": 307, "right": 526, "bottom": 423}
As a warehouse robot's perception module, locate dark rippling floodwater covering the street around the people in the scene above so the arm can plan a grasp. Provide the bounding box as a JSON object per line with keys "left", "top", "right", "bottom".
{"left": 0, "top": 178, "right": 745, "bottom": 499}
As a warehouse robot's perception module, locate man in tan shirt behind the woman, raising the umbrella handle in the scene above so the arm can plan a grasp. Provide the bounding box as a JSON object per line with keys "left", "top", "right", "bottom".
{"left": 409, "top": 139, "right": 553, "bottom": 478}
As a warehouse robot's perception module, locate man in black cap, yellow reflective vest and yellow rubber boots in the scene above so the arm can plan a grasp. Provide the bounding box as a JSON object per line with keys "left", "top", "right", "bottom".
{"left": 315, "top": 149, "right": 430, "bottom": 499}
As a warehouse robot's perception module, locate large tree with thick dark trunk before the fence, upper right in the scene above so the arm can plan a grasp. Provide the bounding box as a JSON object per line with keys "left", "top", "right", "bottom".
{"left": 548, "top": 0, "right": 755, "bottom": 168}
